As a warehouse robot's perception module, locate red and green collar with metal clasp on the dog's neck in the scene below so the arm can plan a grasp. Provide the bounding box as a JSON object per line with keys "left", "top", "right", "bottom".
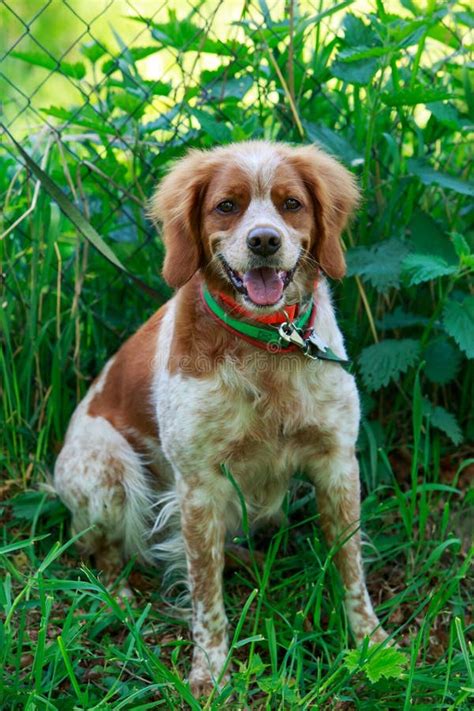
{"left": 200, "top": 283, "right": 348, "bottom": 364}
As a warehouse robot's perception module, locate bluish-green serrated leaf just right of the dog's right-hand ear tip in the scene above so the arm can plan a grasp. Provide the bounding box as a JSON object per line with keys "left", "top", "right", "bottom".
{"left": 346, "top": 239, "right": 408, "bottom": 293}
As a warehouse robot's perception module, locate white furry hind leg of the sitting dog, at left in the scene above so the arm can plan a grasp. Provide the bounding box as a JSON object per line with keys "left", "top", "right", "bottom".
{"left": 54, "top": 406, "right": 153, "bottom": 596}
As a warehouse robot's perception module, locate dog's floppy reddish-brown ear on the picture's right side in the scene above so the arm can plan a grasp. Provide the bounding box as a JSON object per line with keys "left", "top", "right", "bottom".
{"left": 293, "top": 146, "right": 359, "bottom": 279}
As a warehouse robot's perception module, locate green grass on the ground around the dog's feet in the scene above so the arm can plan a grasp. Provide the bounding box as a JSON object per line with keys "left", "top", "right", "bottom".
{"left": 0, "top": 450, "right": 473, "bottom": 709}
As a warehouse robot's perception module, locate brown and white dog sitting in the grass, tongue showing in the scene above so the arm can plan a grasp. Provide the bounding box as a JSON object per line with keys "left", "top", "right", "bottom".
{"left": 55, "top": 141, "right": 386, "bottom": 695}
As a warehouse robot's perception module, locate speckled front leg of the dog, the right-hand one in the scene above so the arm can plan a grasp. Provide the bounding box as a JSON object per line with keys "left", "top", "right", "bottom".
{"left": 310, "top": 448, "right": 387, "bottom": 643}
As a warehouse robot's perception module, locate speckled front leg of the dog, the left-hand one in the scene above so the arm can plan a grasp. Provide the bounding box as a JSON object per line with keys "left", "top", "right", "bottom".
{"left": 179, "top": 480, "right": 228, "bottom": 697}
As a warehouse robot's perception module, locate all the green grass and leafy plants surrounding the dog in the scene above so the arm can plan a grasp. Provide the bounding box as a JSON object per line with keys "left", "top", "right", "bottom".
{"left": 0, "top": 2, "right": 474, "bottom": 711}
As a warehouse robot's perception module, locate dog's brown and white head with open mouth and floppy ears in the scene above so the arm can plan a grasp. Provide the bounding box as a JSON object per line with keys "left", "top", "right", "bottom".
{"left": 150, "top": 141, "right": 358, "bottom": 312}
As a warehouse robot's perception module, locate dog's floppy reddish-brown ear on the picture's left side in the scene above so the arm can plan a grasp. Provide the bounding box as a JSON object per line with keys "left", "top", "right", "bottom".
{"left": 148, "top": 150, "right": 211, "bottom": 289}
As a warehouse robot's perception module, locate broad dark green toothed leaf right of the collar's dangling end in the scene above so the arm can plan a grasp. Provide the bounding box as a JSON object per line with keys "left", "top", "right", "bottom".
{"left": 359, "top": 338, "right": 420, "bottom": 391}
